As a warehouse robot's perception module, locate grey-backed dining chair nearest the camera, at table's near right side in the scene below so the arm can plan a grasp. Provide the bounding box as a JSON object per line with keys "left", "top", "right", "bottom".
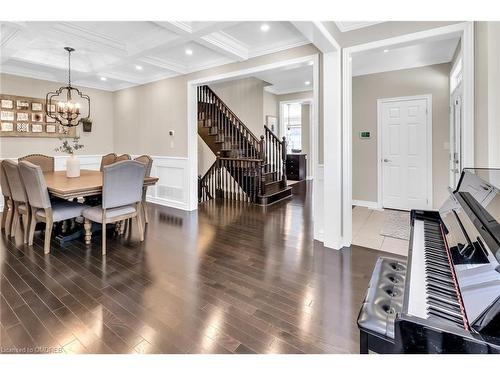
{"left": 83, "top": 160, "right": 146, "bottom": 255}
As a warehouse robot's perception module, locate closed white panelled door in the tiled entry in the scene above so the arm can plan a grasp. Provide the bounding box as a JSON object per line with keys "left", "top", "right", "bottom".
{"left": 379, "top": 97, "right": 432, "bottom": 210}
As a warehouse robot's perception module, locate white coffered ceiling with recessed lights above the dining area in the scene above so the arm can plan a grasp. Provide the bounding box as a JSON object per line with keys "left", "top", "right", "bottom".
{"left": 0, "top": 21, "right": 308, "bottom": 91}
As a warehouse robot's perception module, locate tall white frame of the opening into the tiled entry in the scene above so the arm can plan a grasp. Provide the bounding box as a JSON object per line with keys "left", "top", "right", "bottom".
{"left": 342, "top": 21, "right": 474, "bottom": 246}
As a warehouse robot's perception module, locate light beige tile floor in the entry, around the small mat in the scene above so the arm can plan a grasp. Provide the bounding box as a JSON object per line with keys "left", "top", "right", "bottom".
{"left": 352, "top": 206, "right": 409, "bottom": 256}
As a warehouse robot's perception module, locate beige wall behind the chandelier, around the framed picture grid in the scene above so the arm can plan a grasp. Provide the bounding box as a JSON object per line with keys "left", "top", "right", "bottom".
{"left": 0, "top": 74, "right": 115, "bottom": 158}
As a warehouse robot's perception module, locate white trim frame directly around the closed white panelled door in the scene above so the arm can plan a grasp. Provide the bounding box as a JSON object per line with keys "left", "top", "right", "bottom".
{"left": 377, "top": 94, "right": 433, "bottom": 209}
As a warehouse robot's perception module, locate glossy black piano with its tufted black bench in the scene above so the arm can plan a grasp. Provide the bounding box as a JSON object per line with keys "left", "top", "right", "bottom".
{"left": 358, "top": 169, "right": 500, "bottom": 353}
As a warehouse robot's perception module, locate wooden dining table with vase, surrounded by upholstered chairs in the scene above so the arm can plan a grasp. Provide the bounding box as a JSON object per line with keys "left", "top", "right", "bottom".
{"left": 43, "top": 169, "right": 158, "bottom": 243}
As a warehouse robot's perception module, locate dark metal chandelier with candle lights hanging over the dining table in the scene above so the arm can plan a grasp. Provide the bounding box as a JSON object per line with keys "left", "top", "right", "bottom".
{"left": 45, "top": 47, "right": 90, "bottom": 127}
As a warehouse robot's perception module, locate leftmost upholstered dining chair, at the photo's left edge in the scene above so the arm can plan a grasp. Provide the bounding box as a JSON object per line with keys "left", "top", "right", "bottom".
{"left": 3, "top": 160, "right": 30, "bottom": 243}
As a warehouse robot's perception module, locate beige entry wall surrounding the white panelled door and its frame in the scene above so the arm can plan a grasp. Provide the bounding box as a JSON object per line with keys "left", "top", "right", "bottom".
{"left": 352, "top": 64, "right": 451, "bottom": 207}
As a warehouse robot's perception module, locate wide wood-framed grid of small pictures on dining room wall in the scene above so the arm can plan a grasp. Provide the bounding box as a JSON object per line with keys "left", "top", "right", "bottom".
{"left": 0, "top": 94, "right": 76, "bottom": 138}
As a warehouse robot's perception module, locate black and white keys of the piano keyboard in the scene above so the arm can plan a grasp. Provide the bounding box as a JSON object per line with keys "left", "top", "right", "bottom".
{"left": 408, "top": 220, "right": 467, "bottom": 329}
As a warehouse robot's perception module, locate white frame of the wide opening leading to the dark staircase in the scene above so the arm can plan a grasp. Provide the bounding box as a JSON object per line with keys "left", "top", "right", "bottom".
{"left": 187, "top": 54, "right": 320, "bottom": 211}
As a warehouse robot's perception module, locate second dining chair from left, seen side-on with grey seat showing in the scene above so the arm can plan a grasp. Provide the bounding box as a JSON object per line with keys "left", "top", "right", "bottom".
{"left": 19, "top": 161, "right": 87, "bottom": 254}
